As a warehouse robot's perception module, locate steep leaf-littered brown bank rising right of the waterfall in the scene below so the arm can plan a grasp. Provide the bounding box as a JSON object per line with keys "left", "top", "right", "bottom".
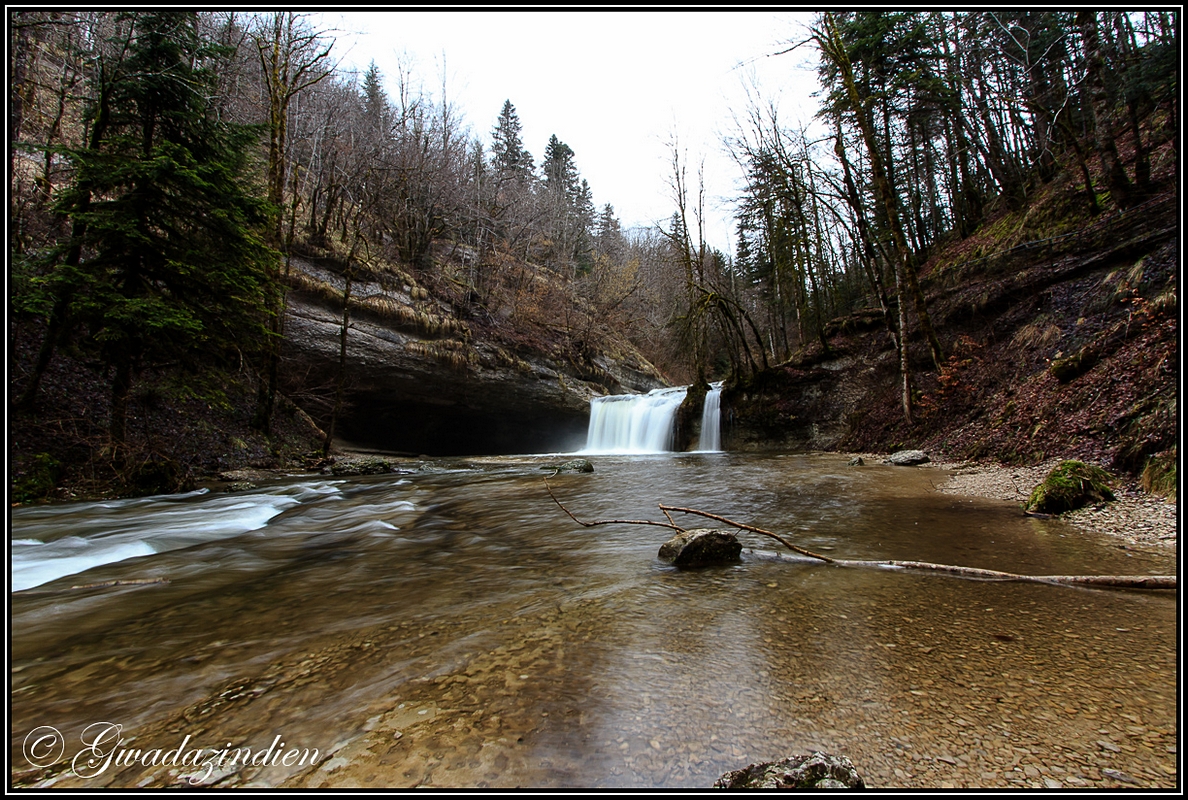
{"left": 722, "top": 194, "right": 1180, "bottom": 472}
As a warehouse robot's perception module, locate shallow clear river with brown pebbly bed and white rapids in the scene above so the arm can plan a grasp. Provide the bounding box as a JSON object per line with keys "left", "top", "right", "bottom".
{"left": 11, "top": 453, "right": 1178, "bottom": 788}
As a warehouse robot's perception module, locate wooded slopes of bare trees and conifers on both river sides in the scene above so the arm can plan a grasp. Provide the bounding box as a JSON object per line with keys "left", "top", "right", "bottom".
{"left": 8, "top": 10, "right": 1180, "bottom": 502}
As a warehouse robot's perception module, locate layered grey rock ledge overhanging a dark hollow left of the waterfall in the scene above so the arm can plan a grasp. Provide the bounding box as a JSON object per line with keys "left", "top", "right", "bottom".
{"left": 284, "top": 259, "right": 664, "bottom": 455}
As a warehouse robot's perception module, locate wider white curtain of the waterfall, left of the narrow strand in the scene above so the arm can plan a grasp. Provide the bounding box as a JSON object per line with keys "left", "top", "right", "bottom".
{"left": 583, "top": 386, "right": 689, "bottom": 453}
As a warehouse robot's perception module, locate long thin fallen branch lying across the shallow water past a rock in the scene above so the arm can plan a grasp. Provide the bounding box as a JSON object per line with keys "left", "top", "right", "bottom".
{"left": 544, "top": 480, "right": 1176, "bottom": 590}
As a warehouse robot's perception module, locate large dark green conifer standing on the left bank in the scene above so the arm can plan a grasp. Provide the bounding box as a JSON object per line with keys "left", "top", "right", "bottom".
{"left": 31, "top": 12, "right": 276, "bottom": 455}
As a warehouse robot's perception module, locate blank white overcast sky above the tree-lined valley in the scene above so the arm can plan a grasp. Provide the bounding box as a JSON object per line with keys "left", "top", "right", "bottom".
{"left": 312, "top": 11, "right": 816, "bottom": 253}
